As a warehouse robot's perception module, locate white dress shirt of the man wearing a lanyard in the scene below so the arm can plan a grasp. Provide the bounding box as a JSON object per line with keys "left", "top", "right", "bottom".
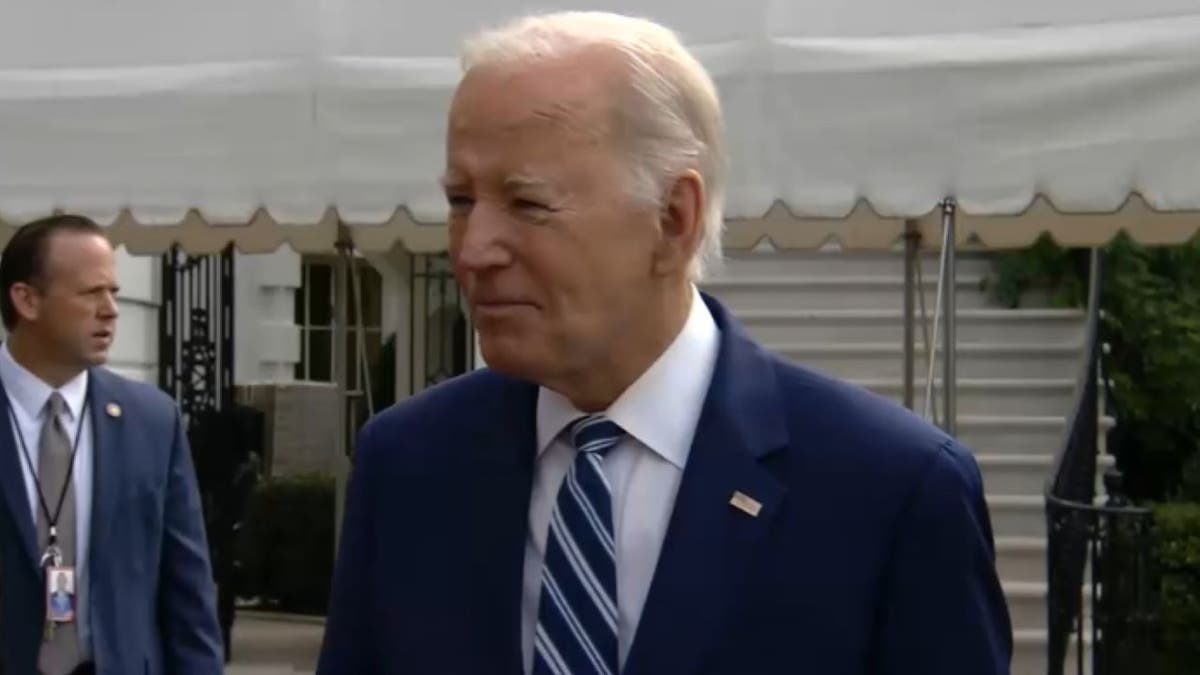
{"left": 0, "top": 341, "right": 94, "bottom": 661}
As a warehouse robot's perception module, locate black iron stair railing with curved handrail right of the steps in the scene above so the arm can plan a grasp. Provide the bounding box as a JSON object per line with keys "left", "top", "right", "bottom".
{"left": 1045, "top": 250, "right": 1156, "bottom": 675}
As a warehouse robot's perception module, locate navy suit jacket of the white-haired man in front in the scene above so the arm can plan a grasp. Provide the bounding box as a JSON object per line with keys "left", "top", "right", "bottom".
{"left": 318, "top": 297, "right": 1012, "bottom": 675}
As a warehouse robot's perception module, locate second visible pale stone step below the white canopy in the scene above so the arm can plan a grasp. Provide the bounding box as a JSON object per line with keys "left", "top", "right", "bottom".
{"left": 701, "top": 274, "right": 990, "bottom": 316}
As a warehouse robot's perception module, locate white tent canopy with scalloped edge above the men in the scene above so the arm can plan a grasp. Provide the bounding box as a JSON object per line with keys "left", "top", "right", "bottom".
{"left": 0, "top": 0, "right": 1200, "bottom": 252}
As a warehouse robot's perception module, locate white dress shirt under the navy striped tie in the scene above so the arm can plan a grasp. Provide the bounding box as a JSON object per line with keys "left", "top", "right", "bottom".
{"left": 521, "top": 289, "right": 720, "bottom": 673}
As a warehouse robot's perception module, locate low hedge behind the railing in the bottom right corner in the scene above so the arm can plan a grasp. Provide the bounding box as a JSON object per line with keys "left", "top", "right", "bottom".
{"left": 1154, "top": 502, "right": 1200, "bottom": 675}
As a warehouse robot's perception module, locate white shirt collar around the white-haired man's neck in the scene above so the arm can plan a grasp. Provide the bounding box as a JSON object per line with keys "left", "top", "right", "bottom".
{"left": 536, "top": 287, "right": 720, "bottom": 468}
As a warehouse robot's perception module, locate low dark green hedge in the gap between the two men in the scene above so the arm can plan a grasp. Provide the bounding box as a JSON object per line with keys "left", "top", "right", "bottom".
{"left": 238, "top": 474, "right": 335, "bottom": 614}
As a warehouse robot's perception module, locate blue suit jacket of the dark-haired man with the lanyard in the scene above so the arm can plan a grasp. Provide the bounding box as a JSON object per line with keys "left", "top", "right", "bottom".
{"left": 0, "top": 368, "right": 224, "bottom": 675}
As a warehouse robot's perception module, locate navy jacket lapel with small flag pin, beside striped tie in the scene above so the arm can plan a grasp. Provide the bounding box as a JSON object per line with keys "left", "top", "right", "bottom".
{"left": 623, "top": 295, "right": 787, "bottom": 675}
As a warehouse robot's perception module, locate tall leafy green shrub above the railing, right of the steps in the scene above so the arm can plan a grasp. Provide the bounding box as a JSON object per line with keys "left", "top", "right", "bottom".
{"left": 988, "top": 235, "right": 1200, "bottom": 502}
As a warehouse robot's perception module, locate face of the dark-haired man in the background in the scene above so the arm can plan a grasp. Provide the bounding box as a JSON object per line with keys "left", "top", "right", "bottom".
{"left": 28, "top": 232, "right": 118, "bottom": 369}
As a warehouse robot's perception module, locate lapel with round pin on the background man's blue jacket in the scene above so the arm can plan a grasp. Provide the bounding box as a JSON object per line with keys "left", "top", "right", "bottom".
{"left": 88, "top": 368, "right": 127, "bottom": 569}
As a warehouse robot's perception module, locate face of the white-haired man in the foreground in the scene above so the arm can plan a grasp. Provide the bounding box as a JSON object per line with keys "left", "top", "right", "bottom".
{"left": 445, "top": 54, "right": 658, "bottom": 383}
